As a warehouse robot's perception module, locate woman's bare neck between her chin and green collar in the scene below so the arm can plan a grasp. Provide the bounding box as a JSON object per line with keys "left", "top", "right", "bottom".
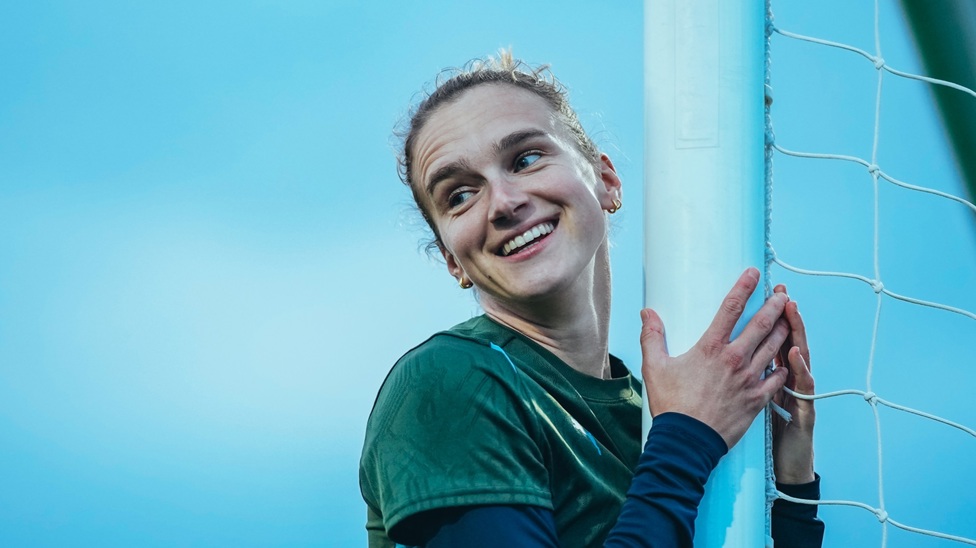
{"left": 481, "top": 244, "right": 610, "bottom": 379}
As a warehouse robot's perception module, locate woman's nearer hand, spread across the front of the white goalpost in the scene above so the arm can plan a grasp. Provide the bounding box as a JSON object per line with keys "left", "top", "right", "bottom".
{"left": 641, "top": 268, "right": 792, "bottom": 448}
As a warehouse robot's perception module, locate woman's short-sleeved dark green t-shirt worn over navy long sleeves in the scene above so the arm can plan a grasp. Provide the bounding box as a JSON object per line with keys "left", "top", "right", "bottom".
{"left": 359, "top": 316, "right": 642, "bottom": 547}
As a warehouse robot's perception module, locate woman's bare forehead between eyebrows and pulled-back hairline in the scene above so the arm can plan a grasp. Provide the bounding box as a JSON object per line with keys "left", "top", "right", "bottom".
{"left": 412, "top": 83, "right": 565, "bottom": 184}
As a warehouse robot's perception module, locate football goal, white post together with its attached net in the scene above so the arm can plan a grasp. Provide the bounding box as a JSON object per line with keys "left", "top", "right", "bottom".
{"left": 645, "top": 0, "right": 976, "bottom": 547}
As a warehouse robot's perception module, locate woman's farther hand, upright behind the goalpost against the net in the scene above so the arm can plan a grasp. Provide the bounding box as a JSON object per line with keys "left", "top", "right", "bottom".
{"left": 773, "top": 285, "right": 816, "bottom": 484}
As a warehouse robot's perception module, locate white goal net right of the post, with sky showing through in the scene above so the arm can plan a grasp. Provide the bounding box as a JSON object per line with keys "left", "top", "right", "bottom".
{"left": 767, "top": 2, "right": 976, "bottom": 546}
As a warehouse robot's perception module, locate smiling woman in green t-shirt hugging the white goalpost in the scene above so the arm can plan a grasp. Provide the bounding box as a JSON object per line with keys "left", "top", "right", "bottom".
{"left": 360, "top": 53, "right": 823, "bottom": 546}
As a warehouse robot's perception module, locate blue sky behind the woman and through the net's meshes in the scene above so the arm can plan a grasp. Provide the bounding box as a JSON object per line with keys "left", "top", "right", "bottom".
{"left": 0, "top": 0, "right": 976, "bottom": 546}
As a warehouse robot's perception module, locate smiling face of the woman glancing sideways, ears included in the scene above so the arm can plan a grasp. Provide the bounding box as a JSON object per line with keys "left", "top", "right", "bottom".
{"left": 412, "top": 84, "right": 620, "bottom": 308}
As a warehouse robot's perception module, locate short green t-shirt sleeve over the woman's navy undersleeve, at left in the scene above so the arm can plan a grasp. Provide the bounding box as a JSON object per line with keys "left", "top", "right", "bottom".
{"left": 360, "top": 336, "right": 552, "bottom": 540}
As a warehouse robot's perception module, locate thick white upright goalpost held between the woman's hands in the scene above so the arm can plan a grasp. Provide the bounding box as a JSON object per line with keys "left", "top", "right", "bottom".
{"left": 644, "top": 0, "right": 768, "bottom": 548}
